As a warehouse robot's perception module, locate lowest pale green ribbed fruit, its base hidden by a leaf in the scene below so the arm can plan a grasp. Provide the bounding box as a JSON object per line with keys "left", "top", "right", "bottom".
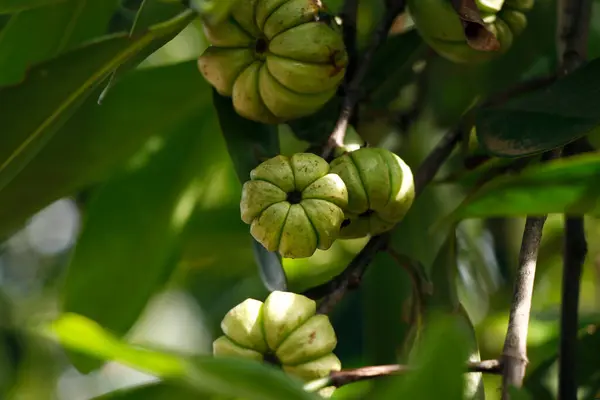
{"left": 213, "top": 291, "right": 341, "bottom": 396}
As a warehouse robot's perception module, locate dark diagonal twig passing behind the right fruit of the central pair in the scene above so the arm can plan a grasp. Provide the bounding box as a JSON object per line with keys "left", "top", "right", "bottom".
{"left": 304, "top": 129, "right": 461, "bottom": 314}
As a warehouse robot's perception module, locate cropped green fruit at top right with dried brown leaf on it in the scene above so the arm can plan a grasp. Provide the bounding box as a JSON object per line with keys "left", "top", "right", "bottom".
{"left": 408, "top": 0, "right": 534, "bottom": 63}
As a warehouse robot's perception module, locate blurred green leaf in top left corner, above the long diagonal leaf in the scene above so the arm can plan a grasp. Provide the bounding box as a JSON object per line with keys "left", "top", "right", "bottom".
{"left": 0, "top": 0, "right": 118, "bottom": 86}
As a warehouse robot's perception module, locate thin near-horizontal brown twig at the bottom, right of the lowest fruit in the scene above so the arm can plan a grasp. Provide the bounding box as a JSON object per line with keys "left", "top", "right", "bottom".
{"left": 305, "top": 360, "right": 502, "bottom": 391}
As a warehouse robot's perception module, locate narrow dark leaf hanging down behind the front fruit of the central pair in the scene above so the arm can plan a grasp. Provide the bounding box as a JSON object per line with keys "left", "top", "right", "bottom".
{"left": 213, "top": 89, "right": 287, "bottom": 290}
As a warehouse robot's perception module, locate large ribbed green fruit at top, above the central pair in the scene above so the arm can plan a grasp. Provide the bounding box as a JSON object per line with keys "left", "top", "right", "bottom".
{"left": 198, "top": 0, "right": 348, "bottom": 124}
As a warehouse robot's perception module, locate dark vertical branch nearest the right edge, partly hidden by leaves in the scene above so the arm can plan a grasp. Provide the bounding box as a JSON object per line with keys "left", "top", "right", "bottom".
{"left": 557, "top": 0, "right": 592, "bottom": 400}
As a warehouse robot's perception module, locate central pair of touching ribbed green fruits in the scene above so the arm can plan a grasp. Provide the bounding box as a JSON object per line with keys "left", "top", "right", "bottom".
{"left": 240, "top": 148, "right": 415, "bottom": 258}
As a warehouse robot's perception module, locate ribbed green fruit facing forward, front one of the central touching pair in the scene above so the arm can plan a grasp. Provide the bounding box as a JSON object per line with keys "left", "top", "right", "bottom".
{"left": 240, "top": 153, "right": 348, "bottom": 258}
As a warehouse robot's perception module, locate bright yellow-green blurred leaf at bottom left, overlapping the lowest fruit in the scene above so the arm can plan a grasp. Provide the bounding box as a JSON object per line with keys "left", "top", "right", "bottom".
{"left": 41, "top": 314, "right": 320, "bottom": 400}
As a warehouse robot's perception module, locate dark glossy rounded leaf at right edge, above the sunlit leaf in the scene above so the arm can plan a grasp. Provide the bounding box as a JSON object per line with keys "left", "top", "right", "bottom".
{"left": 476, "top": 59, "right": 600, "bottom": 157}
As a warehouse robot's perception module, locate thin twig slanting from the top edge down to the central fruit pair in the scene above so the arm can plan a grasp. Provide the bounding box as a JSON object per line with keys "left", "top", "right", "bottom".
{"left": 322, "top": 0, "right": 406, "bottom": 159}
